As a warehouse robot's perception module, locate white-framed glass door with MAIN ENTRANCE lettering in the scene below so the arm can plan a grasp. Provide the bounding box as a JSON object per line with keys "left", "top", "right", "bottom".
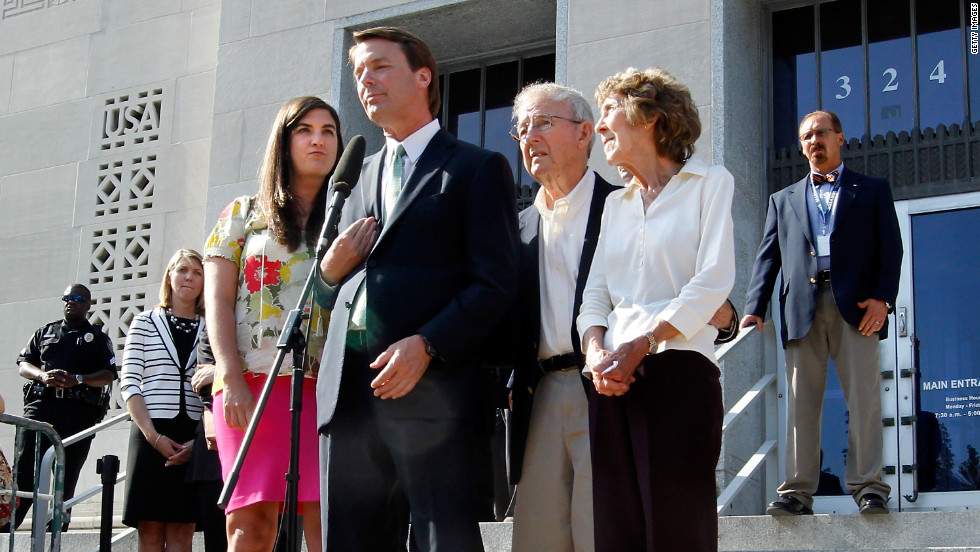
{"left": 886, "top": 193, "right": 980, "bottom": 510}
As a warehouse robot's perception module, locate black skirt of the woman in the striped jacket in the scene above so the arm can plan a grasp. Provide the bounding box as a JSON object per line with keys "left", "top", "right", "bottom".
{"left": 123, "top": 412, "right": 200, "bottom": 527}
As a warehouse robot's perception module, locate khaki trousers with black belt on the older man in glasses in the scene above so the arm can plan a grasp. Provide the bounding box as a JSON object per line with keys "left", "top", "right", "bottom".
{"left": 513, "top": 369, "right": 595, "bottom": 552}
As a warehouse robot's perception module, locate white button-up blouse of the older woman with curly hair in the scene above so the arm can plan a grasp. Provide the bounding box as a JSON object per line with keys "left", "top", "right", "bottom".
{"left": 578, "top": 158, "right": 735, "bottom": 363}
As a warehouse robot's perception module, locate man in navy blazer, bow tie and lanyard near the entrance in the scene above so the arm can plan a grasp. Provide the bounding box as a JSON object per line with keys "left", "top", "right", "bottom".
{"left": 742, "top": 111, "right": 902, "bottom": 515}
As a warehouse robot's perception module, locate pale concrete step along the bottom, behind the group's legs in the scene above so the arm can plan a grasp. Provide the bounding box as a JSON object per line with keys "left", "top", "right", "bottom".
{"left": 0, "top": 510, "right": 980, "bottom": 552}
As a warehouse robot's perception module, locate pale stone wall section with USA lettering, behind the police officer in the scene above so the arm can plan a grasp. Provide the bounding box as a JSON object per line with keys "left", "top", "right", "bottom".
{"left": 0, "top": 0, "right": 220, "bottom": 516}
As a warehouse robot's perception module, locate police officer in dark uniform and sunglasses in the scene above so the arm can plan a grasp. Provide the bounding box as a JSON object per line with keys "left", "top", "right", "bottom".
{"left": 14, "top": 284, "right": 117, "bottom": 530}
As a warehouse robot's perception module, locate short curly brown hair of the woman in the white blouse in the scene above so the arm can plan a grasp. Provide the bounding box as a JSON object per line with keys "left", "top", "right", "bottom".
{"left": 595, "top": 67, "right": 701, "bottom": 163}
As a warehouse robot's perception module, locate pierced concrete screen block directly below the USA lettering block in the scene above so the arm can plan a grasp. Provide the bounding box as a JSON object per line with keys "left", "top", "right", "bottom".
{"left": 94, "top": 153, "right": 157, "bottom": 217}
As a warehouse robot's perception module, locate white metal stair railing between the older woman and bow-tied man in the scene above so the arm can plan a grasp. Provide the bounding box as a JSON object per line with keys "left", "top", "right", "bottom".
{"left": 715, "top": 326, "right": 779, "bottom": 514}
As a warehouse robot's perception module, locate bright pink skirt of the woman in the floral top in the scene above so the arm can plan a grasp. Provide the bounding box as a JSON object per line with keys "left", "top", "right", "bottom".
{"left": 214, "top": 375, "right": 320, "bottom": 514}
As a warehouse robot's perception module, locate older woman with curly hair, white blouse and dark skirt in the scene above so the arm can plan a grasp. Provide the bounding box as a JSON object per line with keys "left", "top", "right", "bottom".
{"left": 577, "top": 68, "right": 735, "bottom": 552}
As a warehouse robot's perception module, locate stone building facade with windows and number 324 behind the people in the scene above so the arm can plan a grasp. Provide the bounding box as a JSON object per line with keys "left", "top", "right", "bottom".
{"left": 0, "top": 0, "right": 980, "bottom": 513}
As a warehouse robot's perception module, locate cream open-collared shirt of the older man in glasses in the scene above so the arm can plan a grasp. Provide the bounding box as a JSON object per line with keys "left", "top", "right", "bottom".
{"left": 534, "top": 171, "right": 595, "bottom": 360}
